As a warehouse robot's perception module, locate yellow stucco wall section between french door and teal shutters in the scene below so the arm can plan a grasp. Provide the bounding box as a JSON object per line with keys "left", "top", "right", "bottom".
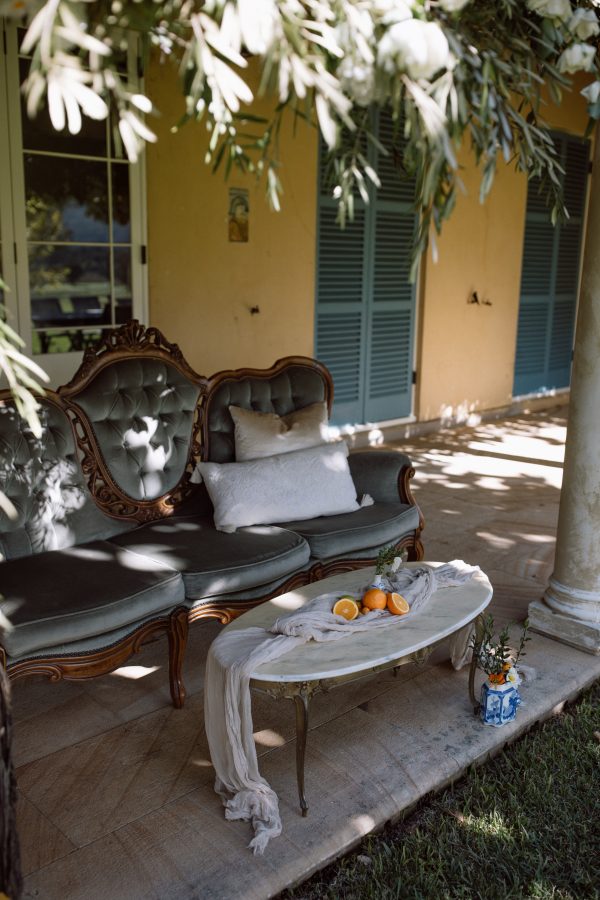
{"left": 146, "top": 61, "right": 317, "bottom": 375}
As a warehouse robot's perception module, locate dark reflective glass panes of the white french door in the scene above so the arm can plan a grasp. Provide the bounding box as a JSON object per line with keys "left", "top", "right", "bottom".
{"left": 19, "top": 44, "right": 138, "bottom": 354}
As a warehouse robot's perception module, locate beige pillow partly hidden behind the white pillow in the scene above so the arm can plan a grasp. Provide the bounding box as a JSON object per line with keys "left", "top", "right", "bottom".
{"left": 229, "top": 403, "right": 327, "bottom": 462}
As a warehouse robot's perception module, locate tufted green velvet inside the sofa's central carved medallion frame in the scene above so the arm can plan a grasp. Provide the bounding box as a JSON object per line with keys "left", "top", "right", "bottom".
{"left": 67, "top": 359, "right": 200, "bottom": 500}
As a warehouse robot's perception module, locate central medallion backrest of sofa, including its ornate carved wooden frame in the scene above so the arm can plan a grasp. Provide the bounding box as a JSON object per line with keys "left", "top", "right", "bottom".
{"left": 58, "top": 320, "right": 206, "bottom": 522}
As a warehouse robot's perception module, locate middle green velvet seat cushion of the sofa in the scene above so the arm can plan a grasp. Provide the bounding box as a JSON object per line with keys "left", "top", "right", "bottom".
{"left": 108, "top": 516, "right": 310, "bottom": 600}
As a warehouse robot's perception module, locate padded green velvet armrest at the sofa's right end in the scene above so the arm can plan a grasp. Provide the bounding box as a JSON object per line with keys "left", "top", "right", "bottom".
{"left": 348, "top": 450, "right": 417, "bottom": 506}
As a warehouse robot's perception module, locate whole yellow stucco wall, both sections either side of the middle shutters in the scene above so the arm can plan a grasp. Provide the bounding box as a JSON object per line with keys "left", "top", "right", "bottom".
{"left": 147, "top": 61, "right": 586, "bottom": 421}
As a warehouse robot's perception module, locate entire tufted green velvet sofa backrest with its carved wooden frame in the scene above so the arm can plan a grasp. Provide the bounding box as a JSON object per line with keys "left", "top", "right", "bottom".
{"left": 0, "top": 321, "right": 333, "bottom": 536}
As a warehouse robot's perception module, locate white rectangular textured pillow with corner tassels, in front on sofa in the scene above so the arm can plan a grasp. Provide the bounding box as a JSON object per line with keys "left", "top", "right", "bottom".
{"left": 194, "top": 441, "right": 359, "bottom": 531}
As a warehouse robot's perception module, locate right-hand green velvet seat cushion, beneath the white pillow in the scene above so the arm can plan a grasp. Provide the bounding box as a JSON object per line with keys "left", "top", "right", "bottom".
{"left": 278, "top": 503, "right": 419, "bottom": 559}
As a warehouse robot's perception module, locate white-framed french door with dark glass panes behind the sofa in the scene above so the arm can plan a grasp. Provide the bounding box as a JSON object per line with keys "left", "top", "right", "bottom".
{"left": 0, "top": 23, "right": 147, "bottom": 386}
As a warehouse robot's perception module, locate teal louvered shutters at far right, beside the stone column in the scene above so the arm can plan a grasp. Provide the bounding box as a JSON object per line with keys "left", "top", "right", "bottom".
{"left": 513, "top": 135, "right": 589, "bottom": 395}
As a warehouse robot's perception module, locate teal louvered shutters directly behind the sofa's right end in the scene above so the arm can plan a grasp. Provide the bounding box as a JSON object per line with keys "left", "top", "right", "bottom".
{"left": 316, "top": 112, "right": 415, "bottom": 424}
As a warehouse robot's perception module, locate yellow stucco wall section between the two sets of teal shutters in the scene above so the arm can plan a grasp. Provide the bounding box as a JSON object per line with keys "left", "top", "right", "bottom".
{"left": 415, "top": 76, "right": 587, "bottom": 421}
